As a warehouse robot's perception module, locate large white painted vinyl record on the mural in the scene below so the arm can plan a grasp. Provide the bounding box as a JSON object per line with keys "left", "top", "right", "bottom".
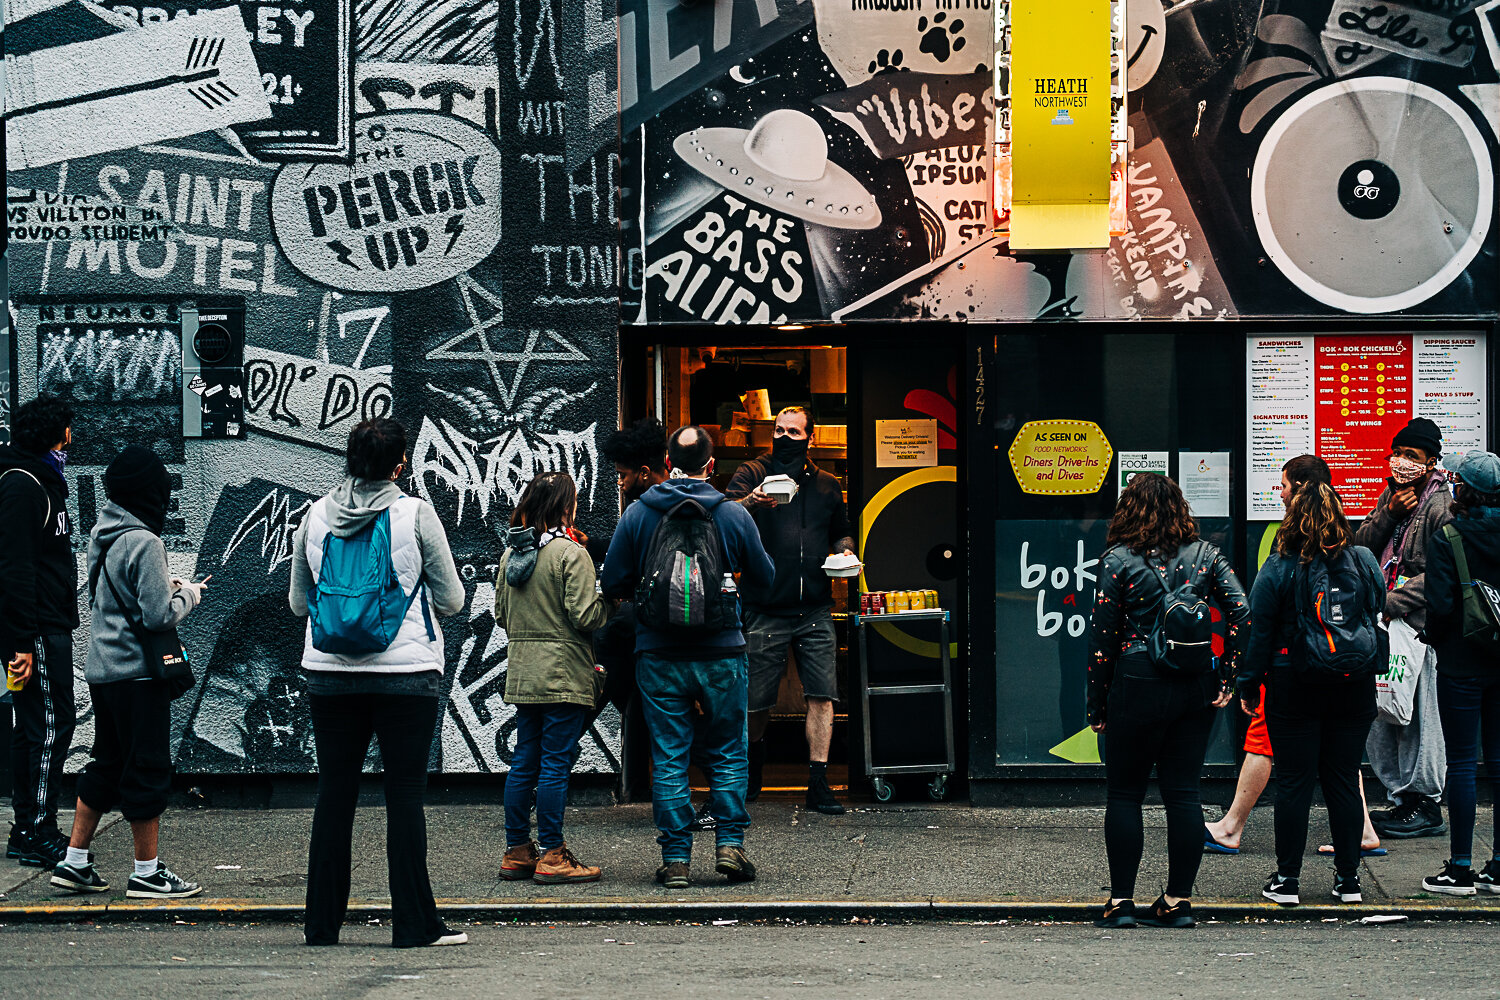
{"left": 1251, "top": 76, "right": 1494, "bottom": 313}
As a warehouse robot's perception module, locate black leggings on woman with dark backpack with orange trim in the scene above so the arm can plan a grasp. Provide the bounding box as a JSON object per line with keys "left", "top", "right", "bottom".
{"left": 1266, "top": 669, "right": 1376, "bottom": 879}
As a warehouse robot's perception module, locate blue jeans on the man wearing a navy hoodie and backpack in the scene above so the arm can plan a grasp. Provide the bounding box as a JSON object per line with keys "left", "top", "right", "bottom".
{"left": 636, "top": 652, "right": 750, "bottom": 864}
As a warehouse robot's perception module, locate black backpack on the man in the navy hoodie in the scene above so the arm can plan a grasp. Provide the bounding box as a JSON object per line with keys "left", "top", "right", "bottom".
{"left": 636, "top": 498, "right": 740, "bottom": 639}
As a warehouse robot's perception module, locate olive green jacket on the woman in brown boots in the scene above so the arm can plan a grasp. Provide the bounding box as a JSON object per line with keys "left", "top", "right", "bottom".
{"left": 495, "top": 538, "right": 609, "bottom": 708}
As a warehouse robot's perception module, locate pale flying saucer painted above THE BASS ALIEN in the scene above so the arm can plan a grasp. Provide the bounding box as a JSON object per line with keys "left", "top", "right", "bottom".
{"left": 672, "top": 108, "right": 881, "bottom": 229}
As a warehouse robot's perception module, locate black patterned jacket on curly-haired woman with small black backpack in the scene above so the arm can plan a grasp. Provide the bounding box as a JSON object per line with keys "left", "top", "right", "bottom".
{"left": 1089, "top": 541, "right": 1250, "bottom": 724}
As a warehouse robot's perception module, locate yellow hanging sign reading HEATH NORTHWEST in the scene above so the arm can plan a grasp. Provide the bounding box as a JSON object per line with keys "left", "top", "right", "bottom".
{"left": 1010, "top": 0, "right": 1115, "bottom": 248}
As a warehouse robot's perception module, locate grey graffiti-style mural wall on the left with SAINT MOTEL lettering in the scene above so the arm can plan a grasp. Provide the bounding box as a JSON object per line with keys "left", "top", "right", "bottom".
{"left": 6, "top": 0, "right": 620, "bottom": 772}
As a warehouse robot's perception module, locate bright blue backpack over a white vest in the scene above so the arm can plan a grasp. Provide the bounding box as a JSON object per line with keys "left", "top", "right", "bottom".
{"left": 308, "top": 510, "right": 438, "bottom": 657}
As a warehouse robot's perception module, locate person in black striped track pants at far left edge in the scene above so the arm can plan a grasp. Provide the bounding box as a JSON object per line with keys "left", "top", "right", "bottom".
{"left": 0, "top": 397, "right": 78, "bottom": 868}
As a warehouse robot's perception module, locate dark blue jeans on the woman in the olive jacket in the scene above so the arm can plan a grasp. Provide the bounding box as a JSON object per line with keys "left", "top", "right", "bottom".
{"left": 506, "top": 705, "right": 590, "bottom": 852}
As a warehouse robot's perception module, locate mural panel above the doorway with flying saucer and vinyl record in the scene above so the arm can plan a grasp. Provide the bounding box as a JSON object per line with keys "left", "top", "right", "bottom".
{"left": 620, "top": 0, "right": 1500, "bottom": 324}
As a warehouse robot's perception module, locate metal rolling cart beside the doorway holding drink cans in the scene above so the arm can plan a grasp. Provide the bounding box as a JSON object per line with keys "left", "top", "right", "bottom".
{"left": 852, "top": 607, "right": 956, "bottom": 802}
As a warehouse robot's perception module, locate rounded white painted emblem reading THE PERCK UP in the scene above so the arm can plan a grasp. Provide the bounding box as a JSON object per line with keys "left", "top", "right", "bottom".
{"left": 272, "top": 111, "right": 500, "bottom": 292}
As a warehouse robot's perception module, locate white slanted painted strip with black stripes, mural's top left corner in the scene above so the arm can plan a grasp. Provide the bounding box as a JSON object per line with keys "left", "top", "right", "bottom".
{"left": 6, "top": 7, "right": 270, "bottom": 169}
